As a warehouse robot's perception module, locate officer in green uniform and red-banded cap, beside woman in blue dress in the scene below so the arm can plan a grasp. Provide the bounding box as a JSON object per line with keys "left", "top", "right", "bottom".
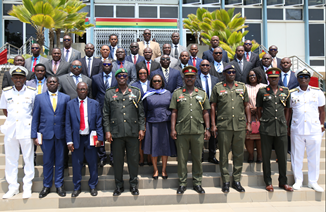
{"left": 170, "top": 66, "right": 210, "bottom": 194}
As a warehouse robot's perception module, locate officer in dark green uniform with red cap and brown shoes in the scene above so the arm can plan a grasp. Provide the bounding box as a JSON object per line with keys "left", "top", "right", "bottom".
{"left": 256, "top": 68, "right": 293, "bottom": 192}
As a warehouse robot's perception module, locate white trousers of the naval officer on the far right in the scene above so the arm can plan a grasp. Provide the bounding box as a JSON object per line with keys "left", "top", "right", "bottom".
{"left": 291, "top": 133, "right": 322, "bottom": 184}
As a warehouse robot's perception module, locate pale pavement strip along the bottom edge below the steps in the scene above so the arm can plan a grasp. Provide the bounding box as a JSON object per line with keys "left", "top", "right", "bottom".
{"left": 3, "top": 201, "right": 325, "bottom": 212}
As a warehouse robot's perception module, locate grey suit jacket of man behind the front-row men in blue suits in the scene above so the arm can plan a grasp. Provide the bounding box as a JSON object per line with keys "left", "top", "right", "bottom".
{"left": 58, "top": 73, "right": 92, "bottom": 99}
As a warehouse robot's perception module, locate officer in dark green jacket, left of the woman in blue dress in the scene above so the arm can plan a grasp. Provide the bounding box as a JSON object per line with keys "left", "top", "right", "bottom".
{"left": 103, "top": 68, "right": 145, "bottom": 196}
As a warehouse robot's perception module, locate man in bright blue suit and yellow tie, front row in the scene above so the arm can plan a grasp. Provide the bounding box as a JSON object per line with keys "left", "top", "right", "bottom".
{"left": 31, "top": 75, "right": 70, "bottom": 198}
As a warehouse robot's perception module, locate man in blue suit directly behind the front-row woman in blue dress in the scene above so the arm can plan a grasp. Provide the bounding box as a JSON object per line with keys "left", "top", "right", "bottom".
{"left": 150, "top": 53, "right": 183, "bottom": 93}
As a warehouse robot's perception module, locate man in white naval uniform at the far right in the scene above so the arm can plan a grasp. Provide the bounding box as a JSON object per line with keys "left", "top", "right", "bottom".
{"left": 290, "top": 68, "right": 325, "bottom": 192}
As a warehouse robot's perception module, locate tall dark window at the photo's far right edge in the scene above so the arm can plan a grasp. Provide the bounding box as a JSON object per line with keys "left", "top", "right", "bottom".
{"left": 309, "top": 24, "right": 325, "bottom": 56}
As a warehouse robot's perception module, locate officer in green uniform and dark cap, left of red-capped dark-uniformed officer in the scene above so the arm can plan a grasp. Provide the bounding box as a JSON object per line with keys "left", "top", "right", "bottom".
{"left": 210, "top": 65, "right": 251, "bottom": 193}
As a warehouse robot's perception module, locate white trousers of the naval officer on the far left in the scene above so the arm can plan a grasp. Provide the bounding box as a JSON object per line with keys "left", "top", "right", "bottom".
{"left": 4, "top": 136, "right": 34, "bottom": 191}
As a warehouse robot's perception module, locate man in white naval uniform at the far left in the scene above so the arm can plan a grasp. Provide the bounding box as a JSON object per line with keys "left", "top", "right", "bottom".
{"left": 0, "top": 66, "right": 37, "bottom": 199}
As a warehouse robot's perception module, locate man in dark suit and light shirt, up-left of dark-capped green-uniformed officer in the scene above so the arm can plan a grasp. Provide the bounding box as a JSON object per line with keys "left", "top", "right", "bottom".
{"left": 210, "top": 47, "right": 227, "bottom": 82}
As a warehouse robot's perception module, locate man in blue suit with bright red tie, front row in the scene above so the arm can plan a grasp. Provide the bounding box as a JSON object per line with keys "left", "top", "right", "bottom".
{"left": 66, "top": 82, "right": 104, "bottom": 197}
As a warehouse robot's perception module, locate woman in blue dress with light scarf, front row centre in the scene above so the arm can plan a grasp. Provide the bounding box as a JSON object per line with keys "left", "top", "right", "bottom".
{"left": 143, "top": 74, "right": 176, "bottom": 180}
